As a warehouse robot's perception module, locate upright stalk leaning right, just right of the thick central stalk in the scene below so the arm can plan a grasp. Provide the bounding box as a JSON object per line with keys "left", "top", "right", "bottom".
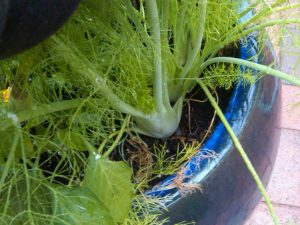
{"left": 179, "top": 0, "right": 207, "bottom": 78}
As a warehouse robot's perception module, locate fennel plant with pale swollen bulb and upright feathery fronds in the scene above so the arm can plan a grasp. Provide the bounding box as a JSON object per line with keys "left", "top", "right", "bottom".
{"left": 49, "top": 0, "right": 299, "bottom": 138}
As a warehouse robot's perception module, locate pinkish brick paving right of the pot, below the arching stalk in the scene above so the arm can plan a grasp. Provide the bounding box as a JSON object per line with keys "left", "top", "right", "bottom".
{"left": 245, "top": 84, "right": 300, "bottom": 225}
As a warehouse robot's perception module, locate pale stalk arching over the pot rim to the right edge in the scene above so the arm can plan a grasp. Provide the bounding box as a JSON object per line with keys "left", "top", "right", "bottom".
{"left": 201, "top": 57, "right": 300, "bottom": 86}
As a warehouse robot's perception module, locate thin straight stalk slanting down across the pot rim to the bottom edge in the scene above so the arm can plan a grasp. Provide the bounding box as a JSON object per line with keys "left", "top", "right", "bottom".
{"left": 197, "top": 79, "right": 279, "bottom": 225}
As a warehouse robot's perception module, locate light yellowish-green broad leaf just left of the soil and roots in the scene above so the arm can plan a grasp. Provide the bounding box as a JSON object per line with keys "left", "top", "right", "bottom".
{"left": 83, "top": 155, "right": 133, "bottom": 223}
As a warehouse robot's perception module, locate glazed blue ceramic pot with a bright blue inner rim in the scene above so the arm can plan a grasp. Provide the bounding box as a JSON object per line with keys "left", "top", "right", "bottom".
{"left": 146, "top": 28, "right": 280, "bottom": 225}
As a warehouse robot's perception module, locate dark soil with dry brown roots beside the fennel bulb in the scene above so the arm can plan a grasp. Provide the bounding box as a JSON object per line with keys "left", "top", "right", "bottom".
{"left": 111, "top": 86, "right": 232, "bottom": 186}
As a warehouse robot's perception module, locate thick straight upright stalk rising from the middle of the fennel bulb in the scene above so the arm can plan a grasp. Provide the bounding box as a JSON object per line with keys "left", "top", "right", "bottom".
{"left": 146, "top": 0, "right": 164, "bottom": 112}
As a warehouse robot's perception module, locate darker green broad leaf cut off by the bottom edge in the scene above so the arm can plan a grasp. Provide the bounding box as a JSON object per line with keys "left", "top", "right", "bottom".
{"left": 53, "top": 187, "right": 114, "bottom": 225}
